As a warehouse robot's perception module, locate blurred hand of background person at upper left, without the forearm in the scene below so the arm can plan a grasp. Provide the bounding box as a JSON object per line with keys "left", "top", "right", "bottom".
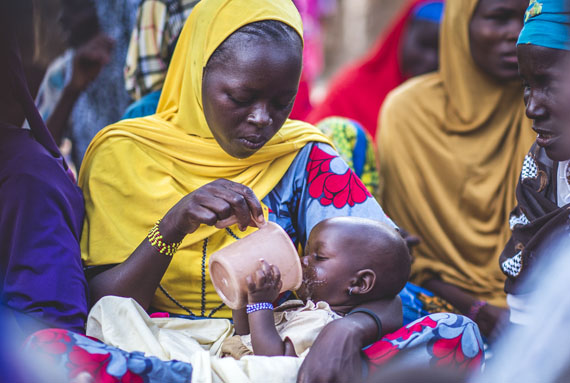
{"left": 70, "top": 33, "right": 115, "bottom": 92}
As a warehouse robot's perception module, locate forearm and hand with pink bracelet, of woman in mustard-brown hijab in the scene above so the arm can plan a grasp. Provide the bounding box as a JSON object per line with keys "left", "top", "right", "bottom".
{"left": 423, "top": 279, "right": 508, "bottom": 339}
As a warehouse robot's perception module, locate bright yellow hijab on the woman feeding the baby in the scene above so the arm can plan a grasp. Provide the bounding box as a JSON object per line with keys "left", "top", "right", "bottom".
{"left": 79, "top": 0, "right": 328, "bottom": 317}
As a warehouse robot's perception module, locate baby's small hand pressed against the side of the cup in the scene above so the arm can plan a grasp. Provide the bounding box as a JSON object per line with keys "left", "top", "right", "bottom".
{"left": 245, "top": 259, "right": 283, "bottom": 304}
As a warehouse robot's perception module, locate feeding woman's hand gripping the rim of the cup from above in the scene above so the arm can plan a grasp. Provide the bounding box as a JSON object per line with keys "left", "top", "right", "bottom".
{"left": 160, "top": 179, "right": 265, "bottom": 243}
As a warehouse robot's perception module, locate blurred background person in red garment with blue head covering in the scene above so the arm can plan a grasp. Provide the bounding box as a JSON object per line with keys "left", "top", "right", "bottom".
{"left": 306, "top": 0, "right": 443, "bottom": 137}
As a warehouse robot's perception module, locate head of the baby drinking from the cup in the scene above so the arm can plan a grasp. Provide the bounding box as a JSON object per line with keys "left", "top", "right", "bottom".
{"left": 297, "top": 217, "right": 411, "bottom": 307}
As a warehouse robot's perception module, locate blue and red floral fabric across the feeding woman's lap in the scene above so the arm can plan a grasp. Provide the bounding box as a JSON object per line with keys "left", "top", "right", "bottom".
{"left": 24, "top": 313, "right": 484, "bottom": 383}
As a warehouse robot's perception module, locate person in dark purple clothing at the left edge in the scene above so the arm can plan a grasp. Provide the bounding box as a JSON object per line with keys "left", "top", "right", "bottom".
{"left": 0, "top": 2, "right": 87, "bottom": 336}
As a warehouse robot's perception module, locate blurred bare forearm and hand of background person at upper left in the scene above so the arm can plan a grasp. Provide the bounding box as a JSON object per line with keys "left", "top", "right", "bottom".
{"left": 46, "top": 34, "right": 113, "bottom": 145}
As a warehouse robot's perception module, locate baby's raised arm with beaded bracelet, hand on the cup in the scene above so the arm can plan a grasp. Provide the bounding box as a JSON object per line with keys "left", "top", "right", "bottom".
{"left": 246, "top": 259, "right": 296, "bottom": 356}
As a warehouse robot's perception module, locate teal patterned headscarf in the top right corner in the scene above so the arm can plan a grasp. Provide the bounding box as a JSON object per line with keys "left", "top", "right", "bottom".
{"left": 517, "top": 0, "right": 570, "bottom": 51}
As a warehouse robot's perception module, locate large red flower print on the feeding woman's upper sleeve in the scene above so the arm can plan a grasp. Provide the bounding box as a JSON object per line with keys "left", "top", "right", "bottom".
{"left": 307, "top": 145, "right": 372, "bottom": 209}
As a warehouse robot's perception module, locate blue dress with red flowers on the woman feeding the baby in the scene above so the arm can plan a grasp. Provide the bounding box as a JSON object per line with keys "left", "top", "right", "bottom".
{"left": 18, "top": 143, "right": 484, "bottom": 383}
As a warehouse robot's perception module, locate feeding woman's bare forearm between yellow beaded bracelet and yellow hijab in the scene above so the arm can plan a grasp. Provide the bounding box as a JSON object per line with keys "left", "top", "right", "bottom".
{"left": 89, "top": 239, "right": 172, "bottom": 310}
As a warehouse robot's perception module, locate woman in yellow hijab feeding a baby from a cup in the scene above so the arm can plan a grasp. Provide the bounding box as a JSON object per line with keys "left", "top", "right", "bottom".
{"left": 79, "top": 0, "right": 401, "bottom": 380}
